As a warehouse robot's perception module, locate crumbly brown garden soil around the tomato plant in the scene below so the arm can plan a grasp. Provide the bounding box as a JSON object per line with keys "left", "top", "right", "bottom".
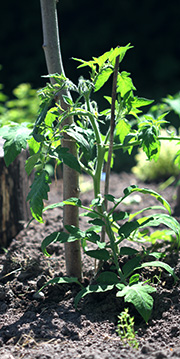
{"left": 0, "top": 173, "right": 180, "bottom": 359}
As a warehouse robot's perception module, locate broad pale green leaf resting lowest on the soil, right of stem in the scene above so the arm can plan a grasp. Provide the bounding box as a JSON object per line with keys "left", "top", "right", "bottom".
{"left": 116, "top": 282, "right": 156, "bottom": 323}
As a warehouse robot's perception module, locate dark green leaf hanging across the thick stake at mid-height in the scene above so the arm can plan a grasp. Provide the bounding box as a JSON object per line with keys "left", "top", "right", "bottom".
{"left": 55, "top": 146, "right": 81, "bottom": 173}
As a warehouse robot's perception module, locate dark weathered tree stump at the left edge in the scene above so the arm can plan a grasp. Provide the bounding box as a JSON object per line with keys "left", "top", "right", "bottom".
{"left": 0, "top": 139, "right": 31, "bottom": 247}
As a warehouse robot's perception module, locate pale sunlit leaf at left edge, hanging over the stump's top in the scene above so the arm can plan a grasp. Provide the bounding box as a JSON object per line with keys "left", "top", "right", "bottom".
{"left": 1, "top": 124, "right": 32, "bottom": 167}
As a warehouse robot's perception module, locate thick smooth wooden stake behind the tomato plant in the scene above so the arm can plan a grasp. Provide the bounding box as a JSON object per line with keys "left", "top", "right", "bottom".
{"left": 40, "top": 0, "right": 81, "bottom": 279}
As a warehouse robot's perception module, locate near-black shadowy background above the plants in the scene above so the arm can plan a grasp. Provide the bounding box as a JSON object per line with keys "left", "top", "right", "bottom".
{"left": 0, "top": 0, "right": 180, "bottom": 104}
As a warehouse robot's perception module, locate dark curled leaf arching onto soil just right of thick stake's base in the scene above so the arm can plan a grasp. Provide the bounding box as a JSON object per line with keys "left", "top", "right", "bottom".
{"left": 74, "top": 284, "right": 114, "bottom": 308}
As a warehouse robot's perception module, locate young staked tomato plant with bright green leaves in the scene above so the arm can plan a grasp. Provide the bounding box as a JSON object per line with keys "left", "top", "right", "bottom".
{"left": 0, "top": 44, "right": 180, "bottom": 322}
